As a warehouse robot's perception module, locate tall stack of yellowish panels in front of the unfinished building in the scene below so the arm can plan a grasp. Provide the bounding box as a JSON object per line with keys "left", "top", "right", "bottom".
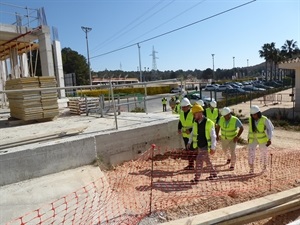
{"left": 5, "top": 77, "right": 58, "bottom": 121}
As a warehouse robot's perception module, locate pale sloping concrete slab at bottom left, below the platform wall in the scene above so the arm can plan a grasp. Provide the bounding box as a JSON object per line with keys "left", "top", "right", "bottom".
{"left": 0, "top": 166, "right": 103, "bottom": 224}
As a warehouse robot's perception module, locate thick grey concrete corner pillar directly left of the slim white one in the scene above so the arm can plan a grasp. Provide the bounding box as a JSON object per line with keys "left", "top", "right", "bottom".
{"left": 37, "top": 26, "right": 55, "bottom": 76}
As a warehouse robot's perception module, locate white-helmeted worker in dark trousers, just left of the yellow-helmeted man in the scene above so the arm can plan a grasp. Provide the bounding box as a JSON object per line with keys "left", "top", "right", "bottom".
{"left": 178, "top": 98, "right": 196, "bottom": 170}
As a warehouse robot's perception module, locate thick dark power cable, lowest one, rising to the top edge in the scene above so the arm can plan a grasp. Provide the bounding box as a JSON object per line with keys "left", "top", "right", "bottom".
{"left": 91, "top": 0, "right": 256, "bottom": 59}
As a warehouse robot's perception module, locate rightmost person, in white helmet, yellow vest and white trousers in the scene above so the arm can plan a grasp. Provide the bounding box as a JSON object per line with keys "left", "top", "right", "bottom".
{"left": 248, "top": 105, "right": 274, "bottom": 174}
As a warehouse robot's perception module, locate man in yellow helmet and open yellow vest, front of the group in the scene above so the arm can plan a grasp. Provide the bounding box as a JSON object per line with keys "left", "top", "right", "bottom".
{"left": 187, "top": 104, "right": 217, "bottom": 183}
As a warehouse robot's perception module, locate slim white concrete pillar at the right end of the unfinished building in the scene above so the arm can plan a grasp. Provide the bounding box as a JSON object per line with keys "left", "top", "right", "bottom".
{"left": 53, "top": 41, "right": 66, "bottom": 98}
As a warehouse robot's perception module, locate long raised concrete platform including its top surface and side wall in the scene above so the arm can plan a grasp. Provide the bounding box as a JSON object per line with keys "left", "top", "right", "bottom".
{"left": 0, "top": 113, "right": 181, "bottom": 186}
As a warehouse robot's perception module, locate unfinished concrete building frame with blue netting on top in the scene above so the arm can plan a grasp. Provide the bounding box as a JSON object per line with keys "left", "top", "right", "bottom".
{"left": 0, "top": 3, "right": 65, "bottom": 103}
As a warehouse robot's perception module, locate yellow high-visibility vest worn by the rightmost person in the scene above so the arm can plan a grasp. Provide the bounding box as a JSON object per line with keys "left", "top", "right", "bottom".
{"left": 248, "top": 116, "right": 269, "bottom": 144}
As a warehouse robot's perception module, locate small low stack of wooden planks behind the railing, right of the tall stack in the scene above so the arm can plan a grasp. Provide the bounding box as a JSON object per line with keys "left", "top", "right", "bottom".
{"left": 68, "top": 98, "right": 99, "bottom": 115}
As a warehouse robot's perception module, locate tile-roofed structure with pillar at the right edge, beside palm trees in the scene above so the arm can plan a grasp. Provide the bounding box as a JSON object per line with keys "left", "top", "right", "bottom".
{"left": 278, "top": 57, "right": 300, "bottom": 112}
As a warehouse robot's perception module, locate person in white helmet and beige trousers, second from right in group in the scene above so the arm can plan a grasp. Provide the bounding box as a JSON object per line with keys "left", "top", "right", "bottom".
{"left": 216, "top": 107, "right": 244, "bottom": 170}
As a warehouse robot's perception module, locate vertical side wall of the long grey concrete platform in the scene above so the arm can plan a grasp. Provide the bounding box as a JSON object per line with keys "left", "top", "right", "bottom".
{"left": 0, "top": 120, "right": 178, "bottom": 186}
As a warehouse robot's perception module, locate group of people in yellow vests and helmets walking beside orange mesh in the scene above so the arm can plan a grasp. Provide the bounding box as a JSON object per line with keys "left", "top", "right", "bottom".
{"left": 178, "top": 98, "right": 274, "bottom": 183}
